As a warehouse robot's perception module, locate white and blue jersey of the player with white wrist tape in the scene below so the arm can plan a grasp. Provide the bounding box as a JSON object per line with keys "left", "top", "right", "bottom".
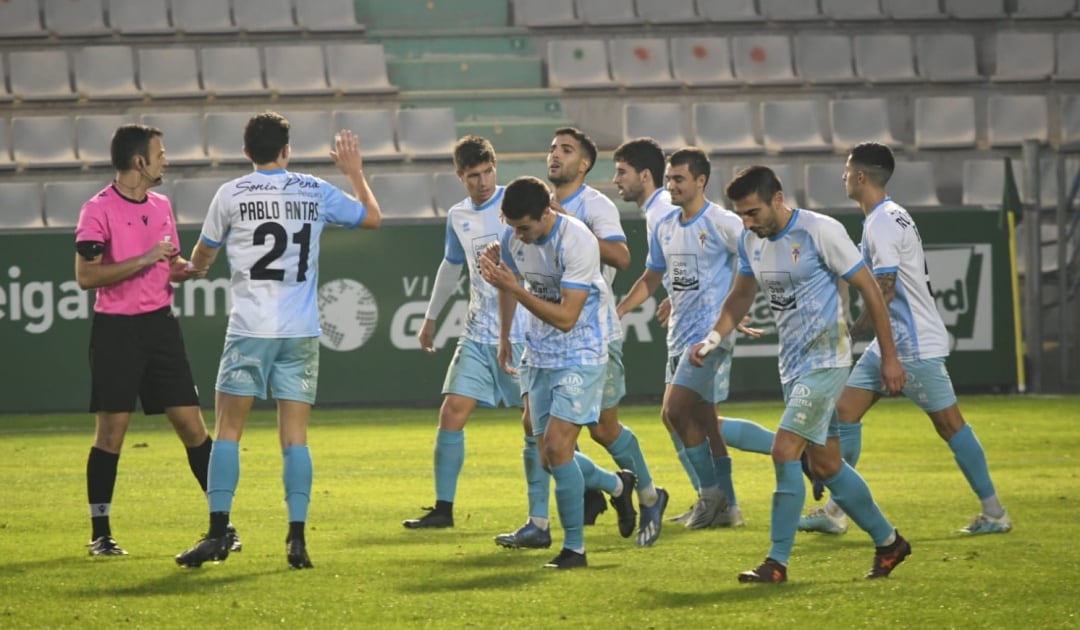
{"left": 739, "top": 209, "right": 863, "bottom": 383}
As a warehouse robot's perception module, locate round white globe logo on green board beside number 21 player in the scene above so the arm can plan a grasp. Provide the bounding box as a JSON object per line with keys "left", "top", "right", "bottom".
{"left": 319, "top": 278, "right": 379, "bottom": 352}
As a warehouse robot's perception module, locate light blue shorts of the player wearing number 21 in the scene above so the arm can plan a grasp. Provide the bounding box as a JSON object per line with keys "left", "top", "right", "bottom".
{"left": 216, "top": 335, "right": 319, "bottom": 404}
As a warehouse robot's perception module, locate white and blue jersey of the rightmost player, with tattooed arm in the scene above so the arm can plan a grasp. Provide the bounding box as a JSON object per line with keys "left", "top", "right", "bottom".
{"left": 860, "top": 197, "right": 948, "bottom": 361}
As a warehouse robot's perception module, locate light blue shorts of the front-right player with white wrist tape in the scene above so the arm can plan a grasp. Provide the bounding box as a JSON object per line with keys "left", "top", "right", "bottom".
{"left": 780, "top": 367, "right": 849, "bottom": 446}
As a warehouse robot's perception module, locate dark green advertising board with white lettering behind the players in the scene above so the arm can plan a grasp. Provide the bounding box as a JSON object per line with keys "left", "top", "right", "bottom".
{"left": 0, "top": 210, "right": 1016, "bottom": 412}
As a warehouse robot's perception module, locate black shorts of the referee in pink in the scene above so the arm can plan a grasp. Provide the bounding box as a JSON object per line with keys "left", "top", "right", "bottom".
{"left": 90, "top": 307, "right": 199, "bottom": 415}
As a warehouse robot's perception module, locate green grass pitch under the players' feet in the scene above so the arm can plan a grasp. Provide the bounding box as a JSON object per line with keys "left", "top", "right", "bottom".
{"left": 0, "top": 397, "right": 1080, "bottom": 628}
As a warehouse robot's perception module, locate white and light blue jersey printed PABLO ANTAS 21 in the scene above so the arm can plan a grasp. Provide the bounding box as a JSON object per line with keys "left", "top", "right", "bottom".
{"left": 201, "top": 169, "right": 367, "bottom": 338}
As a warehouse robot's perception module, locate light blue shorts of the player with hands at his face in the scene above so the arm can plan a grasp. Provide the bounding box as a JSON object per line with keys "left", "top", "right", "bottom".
{"left": 523, "top": 365, "right": 605, "bottom": 435}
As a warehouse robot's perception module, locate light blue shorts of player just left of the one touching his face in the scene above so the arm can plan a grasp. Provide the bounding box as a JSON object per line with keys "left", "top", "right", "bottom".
{"left": 443, "top": 337, "right": 525, "bottom": 407}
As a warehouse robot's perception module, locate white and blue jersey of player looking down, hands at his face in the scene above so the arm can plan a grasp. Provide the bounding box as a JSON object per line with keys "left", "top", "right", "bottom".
{"left": 502, "top": 214, "right": 618, "bottom": 367}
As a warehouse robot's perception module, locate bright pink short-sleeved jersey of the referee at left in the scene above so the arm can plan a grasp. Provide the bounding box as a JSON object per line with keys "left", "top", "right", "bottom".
{"left": 75, "top": 184, "right": 180, "bottom": 316}
